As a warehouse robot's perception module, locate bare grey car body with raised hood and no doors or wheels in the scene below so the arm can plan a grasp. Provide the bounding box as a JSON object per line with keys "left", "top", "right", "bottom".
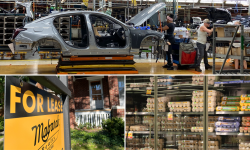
{"left": 9, "top": 3, "right": 166, "bottom": 56}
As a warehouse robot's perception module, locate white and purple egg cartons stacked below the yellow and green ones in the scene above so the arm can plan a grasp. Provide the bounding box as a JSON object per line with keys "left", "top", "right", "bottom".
{"left": 215, "top": 116, "right": 240, "bottom": 132}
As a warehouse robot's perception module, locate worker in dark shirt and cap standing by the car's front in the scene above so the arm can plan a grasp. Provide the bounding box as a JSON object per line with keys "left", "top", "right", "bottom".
{"left": 158, "top": 14, "right": 175, "bottom": 70}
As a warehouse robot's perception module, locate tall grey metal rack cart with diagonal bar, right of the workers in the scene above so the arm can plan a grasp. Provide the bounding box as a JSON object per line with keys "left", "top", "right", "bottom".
{"left": 213, "top": 24, "right": 250, "bottom": 74}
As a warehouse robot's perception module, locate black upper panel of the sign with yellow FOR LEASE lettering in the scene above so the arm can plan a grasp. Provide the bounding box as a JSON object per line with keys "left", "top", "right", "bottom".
{"left": 5, "top": 77, "right": 63, "bottom": 119}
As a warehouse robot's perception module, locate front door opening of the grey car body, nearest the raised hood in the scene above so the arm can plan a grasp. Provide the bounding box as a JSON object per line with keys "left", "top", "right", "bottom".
{"left": 90, "top": 15, "right": 126, "bottom": 48}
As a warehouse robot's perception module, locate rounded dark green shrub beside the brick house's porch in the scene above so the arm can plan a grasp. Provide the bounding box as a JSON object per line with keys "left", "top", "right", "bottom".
{"left": 102, "top": 117, "right": 124, "bottom": 137}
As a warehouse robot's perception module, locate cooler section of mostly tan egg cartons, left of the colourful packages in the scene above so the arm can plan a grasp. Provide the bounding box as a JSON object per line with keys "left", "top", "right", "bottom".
{"left": 126, "top": 76, "right": 207, "bottom": 150}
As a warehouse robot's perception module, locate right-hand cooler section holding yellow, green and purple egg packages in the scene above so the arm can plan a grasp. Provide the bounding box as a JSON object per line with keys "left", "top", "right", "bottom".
{"left": 208, "top": 76, "right": 250, "bottom": 150}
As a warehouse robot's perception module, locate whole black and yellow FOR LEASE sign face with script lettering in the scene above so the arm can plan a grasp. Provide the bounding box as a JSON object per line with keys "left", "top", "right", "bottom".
{"left": 4, "top": 76, "right": 64, "bottom": 150}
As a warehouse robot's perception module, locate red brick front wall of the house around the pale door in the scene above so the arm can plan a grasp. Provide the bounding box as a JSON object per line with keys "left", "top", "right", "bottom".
{"left": 68, "top": 76, "right": 120, "bottom": 128}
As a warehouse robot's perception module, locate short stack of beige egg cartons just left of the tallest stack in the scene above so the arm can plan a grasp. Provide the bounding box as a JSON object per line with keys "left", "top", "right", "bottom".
{"left": 168, "top": 101, "right": 191, "bottom": 112}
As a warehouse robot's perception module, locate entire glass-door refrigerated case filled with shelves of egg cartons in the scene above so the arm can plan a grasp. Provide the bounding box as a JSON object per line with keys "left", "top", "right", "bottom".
{"left": 126, "top": 76, "right": 250, "bottom": 150}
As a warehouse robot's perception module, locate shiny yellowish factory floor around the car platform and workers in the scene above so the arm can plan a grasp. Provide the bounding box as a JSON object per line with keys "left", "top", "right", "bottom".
{"left": 0, "top": 53, "right": 238, "bottom": 75}
